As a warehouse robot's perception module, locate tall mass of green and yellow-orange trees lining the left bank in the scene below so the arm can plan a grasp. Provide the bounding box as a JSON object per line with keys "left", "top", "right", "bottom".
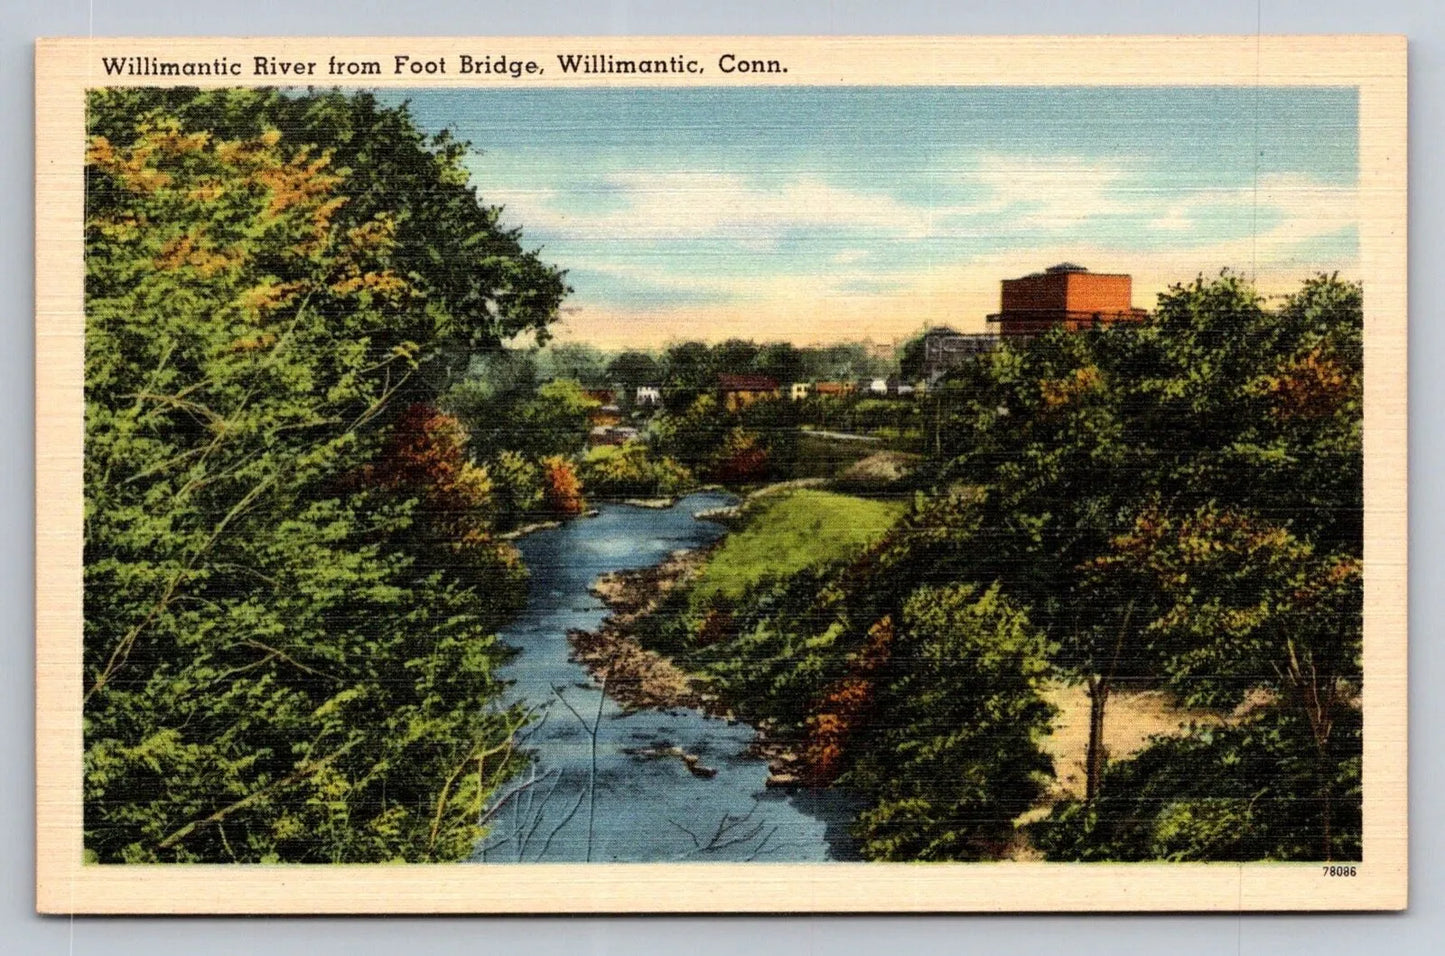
{"left": 84, "top": 90, "right": 578, "bottom": 862}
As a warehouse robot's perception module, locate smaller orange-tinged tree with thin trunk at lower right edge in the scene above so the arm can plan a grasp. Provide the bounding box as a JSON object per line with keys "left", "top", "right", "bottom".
{"left": 1098, "top": 505, "right": 1364, "bottom": 859}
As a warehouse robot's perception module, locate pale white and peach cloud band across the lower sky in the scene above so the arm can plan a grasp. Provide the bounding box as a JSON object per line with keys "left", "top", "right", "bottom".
{"left": 487, "top": 148, "right": 1358, "bottom": 345}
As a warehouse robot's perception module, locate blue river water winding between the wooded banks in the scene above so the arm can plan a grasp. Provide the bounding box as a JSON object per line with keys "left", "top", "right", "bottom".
{"left": 474, "top": 492, "right": 853, "bottom": 862}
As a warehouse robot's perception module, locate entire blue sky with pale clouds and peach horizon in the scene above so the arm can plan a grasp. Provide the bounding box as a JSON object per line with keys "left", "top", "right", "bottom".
{"left": 380, "top": 87, "right": 1358, "bottom": 348}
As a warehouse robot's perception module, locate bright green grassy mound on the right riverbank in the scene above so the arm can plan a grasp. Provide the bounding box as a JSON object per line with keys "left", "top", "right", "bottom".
{"left": 692, "top": 488, "right": 907, "bottom": 601}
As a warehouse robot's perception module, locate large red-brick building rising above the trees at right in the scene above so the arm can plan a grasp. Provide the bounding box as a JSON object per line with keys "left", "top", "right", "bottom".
{"left": 988, "top": 263, "right": 1149, "bottom": 338}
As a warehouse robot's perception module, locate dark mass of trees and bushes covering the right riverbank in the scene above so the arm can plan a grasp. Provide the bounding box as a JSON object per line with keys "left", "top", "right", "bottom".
{"left": 646, "top": 274, "right": 1363, "bottom": 859}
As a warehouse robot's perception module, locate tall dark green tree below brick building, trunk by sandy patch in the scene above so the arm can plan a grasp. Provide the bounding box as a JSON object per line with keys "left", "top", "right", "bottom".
{"left": 938, "top": 274, "right": 1363, "bottom": 814}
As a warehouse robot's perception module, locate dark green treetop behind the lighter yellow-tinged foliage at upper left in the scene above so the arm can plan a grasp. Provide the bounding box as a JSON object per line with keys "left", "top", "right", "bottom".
{"left": 88, "top": 87, "right": 569, "bottom": 387}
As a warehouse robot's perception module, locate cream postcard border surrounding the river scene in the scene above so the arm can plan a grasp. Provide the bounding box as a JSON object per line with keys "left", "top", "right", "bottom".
{"left": 35, "top": 36, "right": 1407, "bottom": 914}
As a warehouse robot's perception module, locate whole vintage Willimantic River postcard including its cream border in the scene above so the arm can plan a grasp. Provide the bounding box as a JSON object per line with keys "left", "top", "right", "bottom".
{"left": 36, "top": 36, "right": 1407, "bottom": 913}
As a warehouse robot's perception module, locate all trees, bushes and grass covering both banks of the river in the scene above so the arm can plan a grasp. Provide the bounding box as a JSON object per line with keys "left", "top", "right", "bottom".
{"left": 84, "top": 90, "right": 1363, "bottom": 862}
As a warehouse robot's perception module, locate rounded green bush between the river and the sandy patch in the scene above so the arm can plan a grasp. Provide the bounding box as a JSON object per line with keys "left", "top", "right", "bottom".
{"left": 845, "top": 585, "right": 1052, "bottom": 859}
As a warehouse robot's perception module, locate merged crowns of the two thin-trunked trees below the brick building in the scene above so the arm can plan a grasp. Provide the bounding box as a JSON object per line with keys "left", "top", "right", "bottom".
{"left": 919, "top": 274, "right": 1363, "bottom": 820}
